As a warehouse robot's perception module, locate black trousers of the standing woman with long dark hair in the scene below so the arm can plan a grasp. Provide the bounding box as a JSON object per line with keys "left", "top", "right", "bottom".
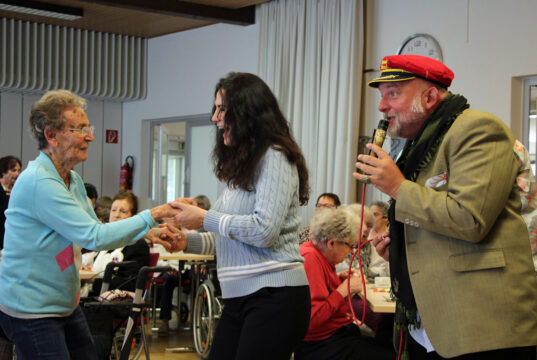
{"left": 209, "top": 286, "right": 311, "bottom": 360}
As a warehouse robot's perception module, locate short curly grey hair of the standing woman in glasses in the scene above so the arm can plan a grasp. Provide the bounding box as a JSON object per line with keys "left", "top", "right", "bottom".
{"left": 30, "top": 90, "right": 86, "bottom": 150}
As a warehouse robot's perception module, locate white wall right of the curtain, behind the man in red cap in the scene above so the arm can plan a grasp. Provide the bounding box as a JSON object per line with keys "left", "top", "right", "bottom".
{"left": 364, "top": 0, "right": 537, "bottom": 134}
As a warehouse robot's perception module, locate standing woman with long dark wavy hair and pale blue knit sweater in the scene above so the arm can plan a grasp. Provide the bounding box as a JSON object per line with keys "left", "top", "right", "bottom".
{"left": 173, "top": 73, "right": 311, "bottom": 360}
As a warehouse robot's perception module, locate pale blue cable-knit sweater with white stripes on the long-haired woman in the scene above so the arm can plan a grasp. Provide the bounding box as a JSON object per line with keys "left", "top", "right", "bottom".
{"left": 187, "top": 148, "right": 308, "bottom": 298}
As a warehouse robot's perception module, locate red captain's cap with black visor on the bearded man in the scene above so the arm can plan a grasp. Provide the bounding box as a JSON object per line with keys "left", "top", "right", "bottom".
{"left": 368, "top": 55, "right": 455, "bottom": 88}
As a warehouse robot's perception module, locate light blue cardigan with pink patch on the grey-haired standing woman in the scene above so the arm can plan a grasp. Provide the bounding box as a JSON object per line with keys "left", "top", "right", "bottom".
{"left": 0, "top": 152, "right": 155, "bottom": 318}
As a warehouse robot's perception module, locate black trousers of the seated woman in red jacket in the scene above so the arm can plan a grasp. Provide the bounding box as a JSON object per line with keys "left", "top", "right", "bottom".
{"left": 295, "top": 324, "right": 395, "bottom": 360}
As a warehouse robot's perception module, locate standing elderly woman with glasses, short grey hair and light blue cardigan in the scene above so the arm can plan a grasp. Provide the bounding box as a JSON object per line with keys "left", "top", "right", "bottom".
{"left": 0, "top": 90, "right": 179, "bottom": 360}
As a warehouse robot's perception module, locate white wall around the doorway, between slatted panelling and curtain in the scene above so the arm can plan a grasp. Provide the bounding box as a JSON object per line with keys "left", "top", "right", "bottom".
{"left": 122, "top": 24, "right": 259, "bottom": 205}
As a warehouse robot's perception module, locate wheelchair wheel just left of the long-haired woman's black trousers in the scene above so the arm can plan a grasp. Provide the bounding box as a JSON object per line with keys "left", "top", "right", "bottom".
{"left": 192, "top": 280, "right": 222, "bottom": 359}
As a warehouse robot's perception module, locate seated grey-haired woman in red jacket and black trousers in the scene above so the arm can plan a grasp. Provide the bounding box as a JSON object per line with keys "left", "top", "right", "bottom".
{"left": 295, "top": 207, "right": 395, "bottom": 360}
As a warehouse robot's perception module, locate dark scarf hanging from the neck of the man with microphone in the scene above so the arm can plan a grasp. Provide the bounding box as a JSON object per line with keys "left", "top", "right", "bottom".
{"left": 388, "top": 93, "right": 469, "bottom": 316}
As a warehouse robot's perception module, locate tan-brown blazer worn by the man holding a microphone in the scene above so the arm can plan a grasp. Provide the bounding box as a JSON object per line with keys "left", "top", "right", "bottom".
{"left": 395, "top": 109, "right": 537, "bottom": 358}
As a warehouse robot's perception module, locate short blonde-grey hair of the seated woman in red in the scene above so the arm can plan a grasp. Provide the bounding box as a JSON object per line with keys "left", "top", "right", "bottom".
{"left": 310, "top": 206, "right": 360, "bottom": 247}
